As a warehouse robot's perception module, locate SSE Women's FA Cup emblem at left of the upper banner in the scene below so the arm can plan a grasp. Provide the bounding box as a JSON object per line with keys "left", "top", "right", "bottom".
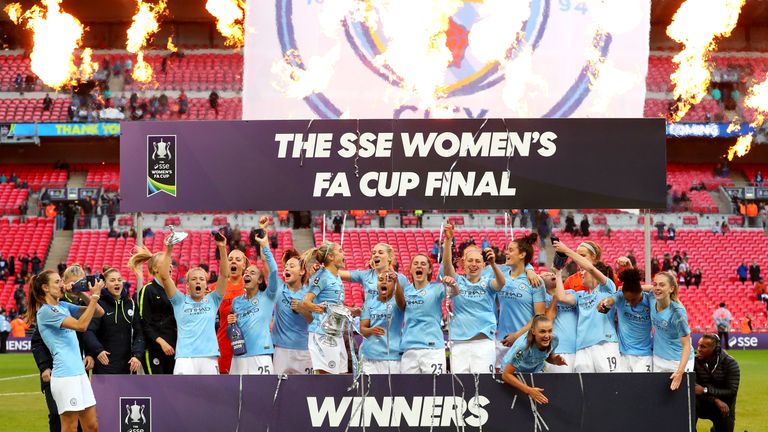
{"left": 147, "top": 135, "right": 177, "bottom": 197}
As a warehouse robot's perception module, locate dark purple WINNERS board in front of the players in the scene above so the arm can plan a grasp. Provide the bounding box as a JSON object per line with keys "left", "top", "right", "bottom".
{"left": 92, "top": 373, "right": 695, "bottom": 432}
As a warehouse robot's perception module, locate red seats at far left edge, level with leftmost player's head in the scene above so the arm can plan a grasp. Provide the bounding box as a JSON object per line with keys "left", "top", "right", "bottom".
{"left": 0, "top": 217, "right": 53, "bottom": 309}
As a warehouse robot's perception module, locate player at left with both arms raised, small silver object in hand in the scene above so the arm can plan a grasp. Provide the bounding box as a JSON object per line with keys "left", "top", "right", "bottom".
{"left": 158, "top": 228, "right": 229, "bottom": 375}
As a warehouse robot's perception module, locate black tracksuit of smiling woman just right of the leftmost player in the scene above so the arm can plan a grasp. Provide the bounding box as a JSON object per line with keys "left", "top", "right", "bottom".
{"left": 83, "top": 288, "right": 144, "bottom": 374}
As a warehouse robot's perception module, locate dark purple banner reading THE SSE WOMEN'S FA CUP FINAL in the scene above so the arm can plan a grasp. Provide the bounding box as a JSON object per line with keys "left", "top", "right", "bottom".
{"left": 120, "top": 119, "right": 666, "bottom": 211}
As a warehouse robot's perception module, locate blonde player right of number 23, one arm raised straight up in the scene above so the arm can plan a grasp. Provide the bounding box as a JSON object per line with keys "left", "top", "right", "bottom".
{"left": 443, "top": 224, "right": 505, "bottom": 373}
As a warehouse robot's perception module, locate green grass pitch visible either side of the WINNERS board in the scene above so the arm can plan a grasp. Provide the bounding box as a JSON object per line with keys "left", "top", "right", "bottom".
{"left": 0, "top": 351, "right": 768, "bottom": 432}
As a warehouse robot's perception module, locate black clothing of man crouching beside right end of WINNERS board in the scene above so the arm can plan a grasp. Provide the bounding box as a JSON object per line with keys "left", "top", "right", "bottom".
{"left": 694, "top": 351, "right": 741, "bottom": 432}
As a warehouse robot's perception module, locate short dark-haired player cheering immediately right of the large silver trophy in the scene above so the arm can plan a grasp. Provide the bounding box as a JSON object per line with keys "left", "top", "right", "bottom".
{"left": 360, "top": 272, "right": 405, "bottom": 375}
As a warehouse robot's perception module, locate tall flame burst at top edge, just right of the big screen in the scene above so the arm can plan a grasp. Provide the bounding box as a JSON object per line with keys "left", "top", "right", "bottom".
{"left": 667, "top": 0, "right": 746, "bottom": 121}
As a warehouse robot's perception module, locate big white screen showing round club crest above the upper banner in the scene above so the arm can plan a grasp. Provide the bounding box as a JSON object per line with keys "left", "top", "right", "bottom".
{"left": 243, "top": 0, "right": 651, "bottom": 120}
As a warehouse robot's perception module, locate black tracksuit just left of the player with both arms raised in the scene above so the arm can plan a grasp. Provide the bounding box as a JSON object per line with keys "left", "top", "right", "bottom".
{"left": 136, "top": 279, "right": 176, "bottom": 374}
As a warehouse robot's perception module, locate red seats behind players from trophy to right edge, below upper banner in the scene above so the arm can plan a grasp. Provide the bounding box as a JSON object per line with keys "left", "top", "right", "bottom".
{"left": 314, "top": 229, "right": 768, "bottom": 330}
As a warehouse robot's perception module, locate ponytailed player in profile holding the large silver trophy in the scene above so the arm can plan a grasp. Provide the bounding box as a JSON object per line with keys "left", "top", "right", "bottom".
{"left": 303, "top": 243, "right": 359, "bottom": 374}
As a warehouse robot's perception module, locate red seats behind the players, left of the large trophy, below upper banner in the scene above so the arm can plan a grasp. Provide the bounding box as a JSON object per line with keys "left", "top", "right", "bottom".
{"left": 67, "top": 229, "right": 293, "bottom": 294}
